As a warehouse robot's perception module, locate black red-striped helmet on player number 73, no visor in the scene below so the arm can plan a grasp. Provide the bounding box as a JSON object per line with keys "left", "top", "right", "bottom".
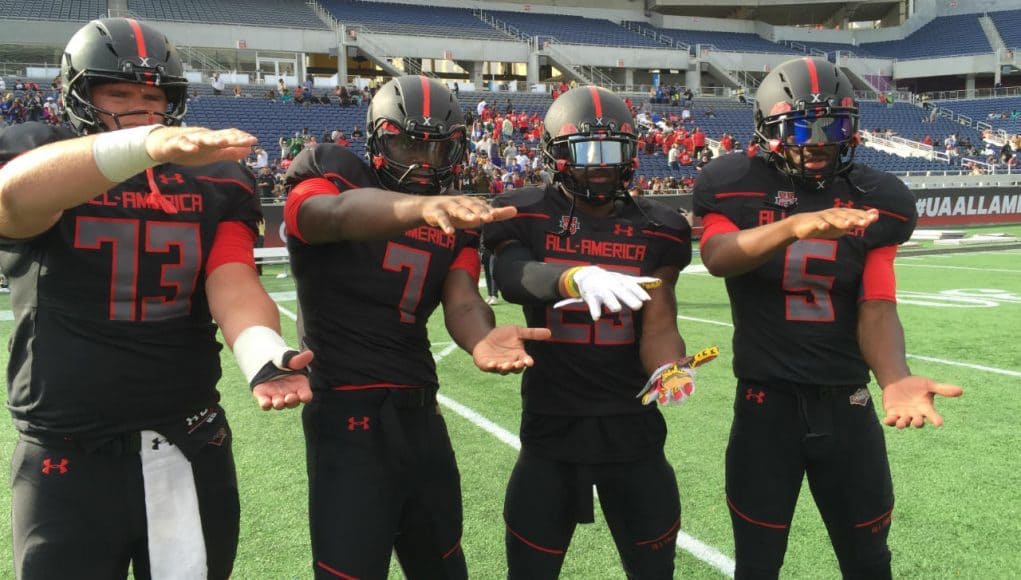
{"left": 60, "top": 18, "right": 188, "bottom": 135}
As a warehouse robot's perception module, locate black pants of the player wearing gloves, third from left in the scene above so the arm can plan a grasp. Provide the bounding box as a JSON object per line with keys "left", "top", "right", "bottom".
{"left": 503, "top": 447, "right": 681, "bottom": 580}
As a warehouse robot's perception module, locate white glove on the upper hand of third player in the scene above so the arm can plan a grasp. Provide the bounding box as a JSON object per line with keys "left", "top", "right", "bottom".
{"left": 553, "top": 265, "right": 663, "bottom": 321}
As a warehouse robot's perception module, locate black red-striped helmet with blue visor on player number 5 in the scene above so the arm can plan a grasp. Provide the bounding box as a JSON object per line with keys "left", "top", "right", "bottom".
{"left": 755, "top": 57, "right": 859, "bottom": 180}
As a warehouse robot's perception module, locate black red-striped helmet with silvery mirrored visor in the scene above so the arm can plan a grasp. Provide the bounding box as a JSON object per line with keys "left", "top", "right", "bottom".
{"left": 540, "top": 87, "right": 638, "bottom": 205}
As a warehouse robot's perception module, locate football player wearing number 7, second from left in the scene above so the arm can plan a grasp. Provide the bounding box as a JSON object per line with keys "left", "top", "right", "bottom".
{"left": 285, "top": 76, "right": 549, "bottom": 579}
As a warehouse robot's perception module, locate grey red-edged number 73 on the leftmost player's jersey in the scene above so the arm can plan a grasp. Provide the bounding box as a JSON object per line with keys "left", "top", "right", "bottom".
{"left": 75, "top": 216, "right": 202, "bottom": 322}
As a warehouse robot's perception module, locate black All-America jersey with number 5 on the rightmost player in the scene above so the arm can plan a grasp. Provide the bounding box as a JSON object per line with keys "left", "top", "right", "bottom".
{"left": 694, "top": 154, "right": 917, "bottom": 386}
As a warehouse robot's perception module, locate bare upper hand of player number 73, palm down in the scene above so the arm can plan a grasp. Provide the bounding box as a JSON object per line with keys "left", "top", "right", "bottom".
{"left": 145, "top": 127, "right": 258, "bottom": 165}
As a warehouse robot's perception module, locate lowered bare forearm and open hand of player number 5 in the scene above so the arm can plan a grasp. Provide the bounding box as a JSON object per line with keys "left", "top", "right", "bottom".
{"left": 858, "top": 300, "right": 964, "bottom": 429}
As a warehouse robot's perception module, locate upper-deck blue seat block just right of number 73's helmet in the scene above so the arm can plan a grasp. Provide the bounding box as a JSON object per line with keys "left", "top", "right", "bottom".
{"left": 125, "top": 0, "right": 329, "bottom": 30}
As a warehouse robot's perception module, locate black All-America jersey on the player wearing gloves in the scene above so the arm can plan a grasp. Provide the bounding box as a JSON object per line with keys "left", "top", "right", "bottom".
{"left": 484, "top": 186, "right": 691, "bottom": 417}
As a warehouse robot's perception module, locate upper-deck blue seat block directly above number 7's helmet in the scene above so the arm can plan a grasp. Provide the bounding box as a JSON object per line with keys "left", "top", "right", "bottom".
{"left": 321, "top": 0, "right": 503, "bottom": 40}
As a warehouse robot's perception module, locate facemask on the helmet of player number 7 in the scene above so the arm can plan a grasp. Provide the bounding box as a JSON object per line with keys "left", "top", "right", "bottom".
{"left": 367, "top": 118, "right": 468, "bottom": 195}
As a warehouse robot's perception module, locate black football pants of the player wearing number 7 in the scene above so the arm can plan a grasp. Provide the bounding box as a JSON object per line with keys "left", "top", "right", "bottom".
{"left": 303, "top": 389, "right": 468, "bottom": 580}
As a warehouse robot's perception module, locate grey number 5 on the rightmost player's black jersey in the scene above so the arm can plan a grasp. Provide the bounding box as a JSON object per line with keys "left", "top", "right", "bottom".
{"left": 783, "top": 240, "right": 836, "bottom": 323}
